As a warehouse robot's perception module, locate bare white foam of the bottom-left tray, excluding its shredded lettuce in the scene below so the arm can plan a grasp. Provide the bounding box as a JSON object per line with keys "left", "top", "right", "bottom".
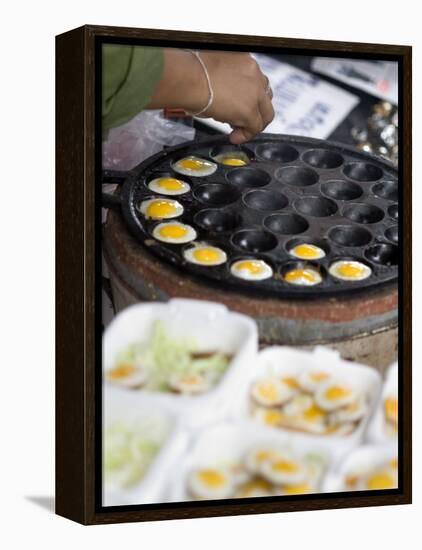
{"left": 102, "top": 387, "right": 188, "bottom": 506}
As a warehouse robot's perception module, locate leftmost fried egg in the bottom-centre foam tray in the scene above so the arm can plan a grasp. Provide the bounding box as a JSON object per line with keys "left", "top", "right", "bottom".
{"left": 187, "top": 467, "right": 235, "bottom": 499}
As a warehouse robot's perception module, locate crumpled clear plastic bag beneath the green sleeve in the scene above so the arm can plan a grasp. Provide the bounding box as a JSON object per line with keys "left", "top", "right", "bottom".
{"left": 103, "top": 110, "right": 195, "bottom": 170}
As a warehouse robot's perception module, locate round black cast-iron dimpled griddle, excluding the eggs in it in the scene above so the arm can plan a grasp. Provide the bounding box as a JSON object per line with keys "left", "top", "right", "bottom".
{"left": 103, "top": 134, "right": 399, "bottom": 298}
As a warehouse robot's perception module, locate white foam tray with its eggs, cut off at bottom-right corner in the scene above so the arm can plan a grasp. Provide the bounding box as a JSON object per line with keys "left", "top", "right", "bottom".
{"left": 323, "top": 443, "right": 398, "bottom": 493}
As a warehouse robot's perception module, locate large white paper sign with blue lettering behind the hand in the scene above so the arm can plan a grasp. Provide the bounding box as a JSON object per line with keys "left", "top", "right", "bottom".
{"left": 198, "top": 54, "right": 359, "bottom": 139}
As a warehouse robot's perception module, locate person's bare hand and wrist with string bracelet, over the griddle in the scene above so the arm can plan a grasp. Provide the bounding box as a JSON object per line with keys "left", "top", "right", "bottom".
{"left": 148, "top": 48, "right": 274, "bottom": 144}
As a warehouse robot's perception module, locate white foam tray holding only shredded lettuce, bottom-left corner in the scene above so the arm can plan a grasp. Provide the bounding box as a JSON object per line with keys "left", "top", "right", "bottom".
{"left": 102, "top": 387, "right": 188, "bottom": 506}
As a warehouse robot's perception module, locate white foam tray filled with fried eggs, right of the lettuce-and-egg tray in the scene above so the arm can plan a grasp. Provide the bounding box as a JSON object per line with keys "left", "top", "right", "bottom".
{"left": 234, "top": 346, "right": 381, "bottom": 456}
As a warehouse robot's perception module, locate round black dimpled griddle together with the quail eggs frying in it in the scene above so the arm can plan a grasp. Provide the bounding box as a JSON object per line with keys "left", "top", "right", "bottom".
{"left": 113, "top": 134, "right": 399, "bottom": 297}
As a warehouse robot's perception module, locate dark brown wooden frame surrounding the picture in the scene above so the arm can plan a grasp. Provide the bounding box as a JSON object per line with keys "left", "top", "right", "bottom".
{"left": 56, "top": 25, "right": 412, "bottom": 525}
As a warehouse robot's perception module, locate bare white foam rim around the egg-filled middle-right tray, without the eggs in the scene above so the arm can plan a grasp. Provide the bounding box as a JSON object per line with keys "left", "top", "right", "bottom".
{"left": 234, "top": 346, "right": 381, "bottom": 458}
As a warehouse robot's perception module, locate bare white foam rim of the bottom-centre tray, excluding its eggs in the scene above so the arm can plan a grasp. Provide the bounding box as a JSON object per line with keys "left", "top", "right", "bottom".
{"left": 165, "top": 421, "right": 342, "bottom": 502}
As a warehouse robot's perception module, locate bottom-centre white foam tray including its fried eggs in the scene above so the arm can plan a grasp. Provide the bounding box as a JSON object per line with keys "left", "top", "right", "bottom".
{"left": 166, "top": 421, "right": 340, "bottom": 502}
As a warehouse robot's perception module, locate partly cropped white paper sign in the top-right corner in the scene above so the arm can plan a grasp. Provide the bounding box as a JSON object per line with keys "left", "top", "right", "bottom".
{"left": 312, "top": 57, "right": 398, "bottom": 105}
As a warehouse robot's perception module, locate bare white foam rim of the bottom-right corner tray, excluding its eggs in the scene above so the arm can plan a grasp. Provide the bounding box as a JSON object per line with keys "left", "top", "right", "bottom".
{"left": 323, "top": 442, "right": 398, "bottom": 493}
